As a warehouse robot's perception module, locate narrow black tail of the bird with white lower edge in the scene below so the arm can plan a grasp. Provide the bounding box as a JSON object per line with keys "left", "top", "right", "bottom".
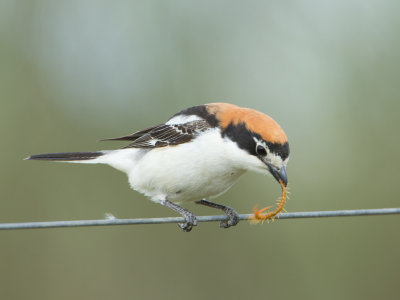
{"left": 25, "top": 151, "right": 107, "bottom": 163}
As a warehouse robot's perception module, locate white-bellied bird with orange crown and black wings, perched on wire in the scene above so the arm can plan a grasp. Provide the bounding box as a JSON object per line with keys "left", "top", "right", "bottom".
{"left": 26, "top": 102, "right": 290, "bottom": 232}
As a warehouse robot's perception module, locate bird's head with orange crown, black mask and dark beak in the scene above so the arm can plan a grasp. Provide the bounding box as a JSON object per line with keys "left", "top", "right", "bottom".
{"left": 207, "top": 103, "right": 290, "bottom": 186}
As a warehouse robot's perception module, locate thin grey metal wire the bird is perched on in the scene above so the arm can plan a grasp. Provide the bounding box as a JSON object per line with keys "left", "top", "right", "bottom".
{"left": 0, "top": 208, "right": 400, "bottom": 230}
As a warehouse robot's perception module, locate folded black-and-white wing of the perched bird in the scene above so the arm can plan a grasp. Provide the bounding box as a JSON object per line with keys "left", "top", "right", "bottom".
{"left": 103, "top": 120, "right": 211, "bottom": 148}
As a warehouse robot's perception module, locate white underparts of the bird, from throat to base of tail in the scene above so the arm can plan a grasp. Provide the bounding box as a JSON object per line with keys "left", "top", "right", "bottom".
{"left": 99, "top": 130, "right": 266, "bottom": 202}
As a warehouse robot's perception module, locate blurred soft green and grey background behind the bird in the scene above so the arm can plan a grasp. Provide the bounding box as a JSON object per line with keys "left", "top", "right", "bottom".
{"left": 0, "top": 0, "right": 400, "bottom": 300}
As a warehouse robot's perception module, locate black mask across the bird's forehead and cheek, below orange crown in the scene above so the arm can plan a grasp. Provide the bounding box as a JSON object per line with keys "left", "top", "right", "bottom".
{"left": 222, "top": 123, "right": 290, "bottom": 160}
